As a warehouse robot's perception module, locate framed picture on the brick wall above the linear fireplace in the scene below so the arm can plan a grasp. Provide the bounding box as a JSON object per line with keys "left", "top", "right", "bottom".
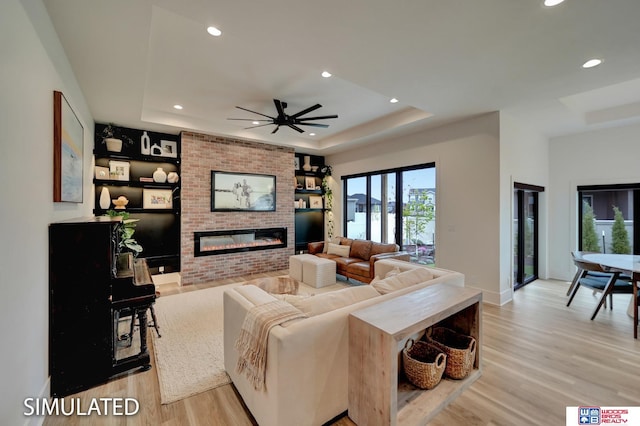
{"left": 211, "top": 170, "right": 276, "bottom": 212}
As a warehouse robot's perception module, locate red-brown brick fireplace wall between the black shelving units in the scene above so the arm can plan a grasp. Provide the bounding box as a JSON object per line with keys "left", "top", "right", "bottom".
{"left": 180, "top": 132, "right": 295, "bottom": 285}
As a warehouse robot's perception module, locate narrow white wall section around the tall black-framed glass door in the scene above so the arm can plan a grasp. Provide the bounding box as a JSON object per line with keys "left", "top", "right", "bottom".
{"left": 500, "top": 112, "right": 549, "bottom": 301}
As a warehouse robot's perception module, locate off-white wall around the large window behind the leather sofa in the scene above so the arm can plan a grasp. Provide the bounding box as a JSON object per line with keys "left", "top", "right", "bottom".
{"left": 327, "top": 113, "right": 504, "bottom": 304}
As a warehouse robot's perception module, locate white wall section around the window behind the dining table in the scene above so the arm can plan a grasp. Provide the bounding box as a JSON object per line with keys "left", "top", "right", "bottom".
{"left": 549, "top": 120, "right": 640, "bottom": 280}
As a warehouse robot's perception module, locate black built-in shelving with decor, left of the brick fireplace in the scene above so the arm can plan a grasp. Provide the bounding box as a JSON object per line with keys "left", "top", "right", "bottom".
{"left": 93, "top": 123, "right": 181, "bottom": 273}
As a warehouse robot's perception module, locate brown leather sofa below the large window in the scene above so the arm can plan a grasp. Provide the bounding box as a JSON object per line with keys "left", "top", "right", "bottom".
{"left": 307, "top": 237, "right": 410, "bottom": 283}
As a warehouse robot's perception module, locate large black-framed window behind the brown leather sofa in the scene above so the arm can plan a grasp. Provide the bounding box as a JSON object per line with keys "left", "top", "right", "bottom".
{"left": 343, "top": 163, "right": 436, "bottom": 264}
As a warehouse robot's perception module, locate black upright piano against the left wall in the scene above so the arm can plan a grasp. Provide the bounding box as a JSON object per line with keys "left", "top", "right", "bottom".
{"left": 49, "top": 218, "right": 155, "bottom": 397}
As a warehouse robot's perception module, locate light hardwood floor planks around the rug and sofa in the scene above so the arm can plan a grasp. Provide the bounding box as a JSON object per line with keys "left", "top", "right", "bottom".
{"left": 44, "top": 273, "right": 640, "bottom": 426}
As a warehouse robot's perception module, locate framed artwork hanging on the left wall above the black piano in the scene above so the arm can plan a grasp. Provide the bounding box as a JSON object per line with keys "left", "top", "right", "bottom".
{"left": 53, "top": 91, "right": 84, "bottom": 203}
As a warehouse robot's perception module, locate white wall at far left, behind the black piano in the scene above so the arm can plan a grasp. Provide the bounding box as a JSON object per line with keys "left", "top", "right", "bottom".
{"left": 0, "top": 0, "right": 93, "bottom": 425}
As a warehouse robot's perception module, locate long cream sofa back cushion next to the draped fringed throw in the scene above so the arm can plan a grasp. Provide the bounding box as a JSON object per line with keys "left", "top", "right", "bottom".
{"left": 290, "top": 285, "right": 380, "bottom": 317}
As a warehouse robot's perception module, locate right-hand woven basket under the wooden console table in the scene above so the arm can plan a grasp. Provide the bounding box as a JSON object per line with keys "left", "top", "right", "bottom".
{"left": 425, "top": 327, "right": 476, "bottom": 379}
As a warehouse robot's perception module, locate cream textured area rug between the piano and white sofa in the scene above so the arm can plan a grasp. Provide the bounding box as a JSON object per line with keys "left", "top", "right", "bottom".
{"left": 149, "top": 284, "right": 239, "bottom": 404}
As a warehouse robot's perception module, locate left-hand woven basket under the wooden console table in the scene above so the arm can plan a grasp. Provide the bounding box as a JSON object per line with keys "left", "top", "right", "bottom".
{"left": 402, "top": 339, "right": 447, "bottom": 389}
